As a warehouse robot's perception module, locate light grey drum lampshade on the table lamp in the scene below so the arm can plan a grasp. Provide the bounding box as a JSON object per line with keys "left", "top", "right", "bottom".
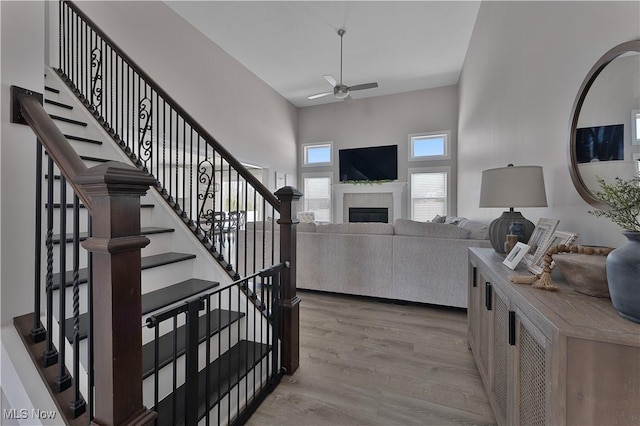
{"left": 480, "top": 166, "right": 547, "bottom": 207}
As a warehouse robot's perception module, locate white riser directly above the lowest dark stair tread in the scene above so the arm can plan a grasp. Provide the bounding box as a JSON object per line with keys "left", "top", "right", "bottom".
{"left": 142, "top": 324, "right": 245, "bottom": 407}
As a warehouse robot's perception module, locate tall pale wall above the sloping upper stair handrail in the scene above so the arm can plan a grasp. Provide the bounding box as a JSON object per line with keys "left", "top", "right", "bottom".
{"left": 76, "top": 1, "right": 297, "bottom": 187}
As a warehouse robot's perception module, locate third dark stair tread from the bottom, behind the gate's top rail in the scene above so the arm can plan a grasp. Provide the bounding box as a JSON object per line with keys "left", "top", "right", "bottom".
{"left": 65, "top": 279, "right": 224, "bottom": 342}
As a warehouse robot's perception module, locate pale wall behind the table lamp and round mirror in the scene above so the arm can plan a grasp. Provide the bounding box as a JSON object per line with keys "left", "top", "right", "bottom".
{"left": 458, "top": 1, "right": 640, "bottom": 246}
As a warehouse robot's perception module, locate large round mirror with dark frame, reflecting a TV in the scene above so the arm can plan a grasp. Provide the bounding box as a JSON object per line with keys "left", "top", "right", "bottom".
{"left": 569, "top": 40, "right": 640, "bottom": 208}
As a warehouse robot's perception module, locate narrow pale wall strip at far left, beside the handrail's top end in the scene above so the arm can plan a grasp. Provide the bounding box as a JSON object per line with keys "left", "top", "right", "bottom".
{"left": 0, "top": 1, "right": 44, "bottom": 326}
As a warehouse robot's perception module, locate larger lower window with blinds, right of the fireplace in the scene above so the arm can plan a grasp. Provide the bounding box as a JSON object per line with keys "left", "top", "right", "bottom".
{"left": 409, "top": 167, "right": 450, "bottom": 222}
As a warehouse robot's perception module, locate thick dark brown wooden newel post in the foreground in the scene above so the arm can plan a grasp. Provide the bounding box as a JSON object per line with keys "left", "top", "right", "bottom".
{"left": 74, "top": 162, "right": 156, "bottom": 426}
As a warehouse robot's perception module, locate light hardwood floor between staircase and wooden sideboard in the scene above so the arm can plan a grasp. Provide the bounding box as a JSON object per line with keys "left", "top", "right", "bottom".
{"left": 248, "top": 292, "right": 495, "bottom": 426}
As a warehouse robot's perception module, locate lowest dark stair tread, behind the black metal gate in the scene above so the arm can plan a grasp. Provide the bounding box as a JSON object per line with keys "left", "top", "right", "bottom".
{"left": 153, "top": 340, "right": 269, "bottom": 425}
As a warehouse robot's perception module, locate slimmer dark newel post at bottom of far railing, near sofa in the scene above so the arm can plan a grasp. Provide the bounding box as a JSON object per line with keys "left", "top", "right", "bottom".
{"left": 274, "top": 186, "right": 302, "bottom": 374}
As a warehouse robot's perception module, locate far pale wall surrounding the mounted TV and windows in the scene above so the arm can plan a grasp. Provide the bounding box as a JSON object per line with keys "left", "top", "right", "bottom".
{"left": 298, "top": 86, "right": 458, "bottom": 218}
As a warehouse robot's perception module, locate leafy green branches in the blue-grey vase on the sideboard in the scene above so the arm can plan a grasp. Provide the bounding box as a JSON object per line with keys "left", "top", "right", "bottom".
{"left": 589, "top": 176, "right": 640, "bottom": 232}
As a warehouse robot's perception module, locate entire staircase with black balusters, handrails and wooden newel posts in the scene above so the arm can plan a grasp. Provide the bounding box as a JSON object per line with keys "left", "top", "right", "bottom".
{"left": 12, "top": 2, "right": 301, "bottom": 425}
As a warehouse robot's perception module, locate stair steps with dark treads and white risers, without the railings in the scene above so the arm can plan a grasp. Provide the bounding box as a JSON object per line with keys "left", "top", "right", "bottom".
{"left": 10, "top": 69, "right": 280, "bottom": 424}
